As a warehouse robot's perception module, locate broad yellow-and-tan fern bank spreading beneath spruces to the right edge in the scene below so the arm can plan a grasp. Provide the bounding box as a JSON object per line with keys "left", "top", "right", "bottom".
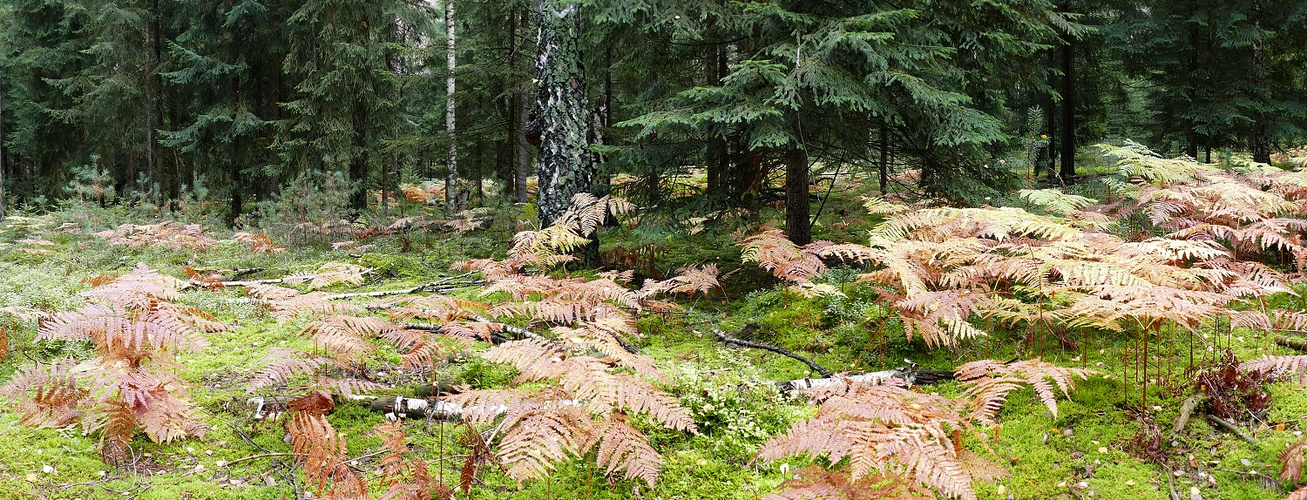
{"left": 742, "top": 182, "right": 1300, "bottom": 346}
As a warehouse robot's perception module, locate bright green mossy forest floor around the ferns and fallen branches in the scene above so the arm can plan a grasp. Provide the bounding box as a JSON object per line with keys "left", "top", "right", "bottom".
{"left": 0, "top": 169, "right": 1307, "bottom": 500}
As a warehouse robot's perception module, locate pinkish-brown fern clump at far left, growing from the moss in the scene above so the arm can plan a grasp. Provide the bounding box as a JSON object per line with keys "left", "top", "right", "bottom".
{"left": 4, "top": 264, "right": 214, "bottom": 461}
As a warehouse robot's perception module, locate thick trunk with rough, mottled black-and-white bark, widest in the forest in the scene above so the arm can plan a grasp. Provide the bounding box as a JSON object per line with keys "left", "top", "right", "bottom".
{"left": 536, "top": 0, "right": 595, "bottom": 227}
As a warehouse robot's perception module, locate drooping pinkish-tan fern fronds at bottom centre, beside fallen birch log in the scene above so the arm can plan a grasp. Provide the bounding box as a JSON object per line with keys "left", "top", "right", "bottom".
{"left": 448, "top": 332, "right": 697, "bottom": 486}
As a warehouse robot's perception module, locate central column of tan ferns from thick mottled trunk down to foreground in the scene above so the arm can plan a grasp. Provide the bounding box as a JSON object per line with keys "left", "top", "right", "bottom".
{"left": 441, "top": 208, "right": 719, "bottom": 486}
